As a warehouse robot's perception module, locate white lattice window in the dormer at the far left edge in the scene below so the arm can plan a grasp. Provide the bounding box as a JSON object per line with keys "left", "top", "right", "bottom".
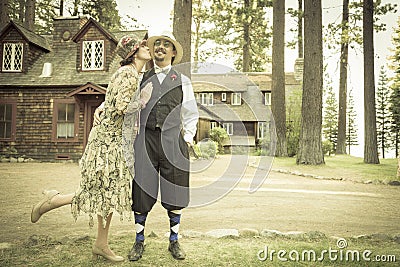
{"left": 2, "top": 43, "right": 24, "bottom": 72}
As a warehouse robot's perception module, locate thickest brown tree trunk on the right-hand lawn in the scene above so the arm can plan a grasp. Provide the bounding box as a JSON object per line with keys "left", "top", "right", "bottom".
{"left": 296, "top": 0, "right": 325, "bottom": 165}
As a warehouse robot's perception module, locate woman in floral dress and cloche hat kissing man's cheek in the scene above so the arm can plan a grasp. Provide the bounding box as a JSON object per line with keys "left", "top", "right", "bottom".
{"left": 31, "top": 36, "right": 153, "bottom": 262}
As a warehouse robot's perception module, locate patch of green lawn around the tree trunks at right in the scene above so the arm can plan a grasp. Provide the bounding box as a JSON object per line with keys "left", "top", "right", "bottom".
{"left": 272, "top": 155, "right": 399, "bottom": 184}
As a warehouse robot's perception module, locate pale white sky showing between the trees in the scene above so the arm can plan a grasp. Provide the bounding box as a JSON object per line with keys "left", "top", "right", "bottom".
{"left": 116, "top": 0, "right": 400, "bottom": 157}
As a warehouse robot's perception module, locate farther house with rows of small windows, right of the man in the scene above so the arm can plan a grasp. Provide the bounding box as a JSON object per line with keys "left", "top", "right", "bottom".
{"left": 192, "top": 72, "right": 301, "bottom": 151}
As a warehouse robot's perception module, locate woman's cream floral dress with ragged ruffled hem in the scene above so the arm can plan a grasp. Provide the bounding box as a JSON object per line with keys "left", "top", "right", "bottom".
{"left": 71, "top": 65, "right": 141, "bottom": 227}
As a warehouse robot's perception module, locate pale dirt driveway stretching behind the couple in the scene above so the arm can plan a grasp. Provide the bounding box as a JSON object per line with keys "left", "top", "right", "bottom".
{"left": 0, "top": 156, "right": 400, "bottom": 245}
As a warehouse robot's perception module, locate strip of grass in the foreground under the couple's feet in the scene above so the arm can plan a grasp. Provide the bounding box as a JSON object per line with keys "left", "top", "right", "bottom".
{"left": 0, "top": 235, "right": 400, "bottom": 267}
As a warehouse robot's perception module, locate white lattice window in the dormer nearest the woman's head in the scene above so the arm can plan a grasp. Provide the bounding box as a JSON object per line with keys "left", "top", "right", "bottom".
{"left": 82, "top": 40, "right": 104, "bottom": 70}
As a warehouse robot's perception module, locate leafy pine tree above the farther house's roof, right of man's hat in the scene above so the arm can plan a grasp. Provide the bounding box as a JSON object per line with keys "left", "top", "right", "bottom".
{"left": 204, "top": 0, "right": 272, "bottom": 72}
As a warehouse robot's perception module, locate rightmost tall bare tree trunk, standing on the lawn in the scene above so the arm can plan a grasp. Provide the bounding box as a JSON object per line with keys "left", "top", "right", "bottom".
{"left": 363, "top": 0, "right": 379, "bottom": 164}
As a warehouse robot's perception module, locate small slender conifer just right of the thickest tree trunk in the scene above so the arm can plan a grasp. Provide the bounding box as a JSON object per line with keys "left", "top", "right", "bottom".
{"left": 322, "top": 81, "right": 338, "bottom": 155}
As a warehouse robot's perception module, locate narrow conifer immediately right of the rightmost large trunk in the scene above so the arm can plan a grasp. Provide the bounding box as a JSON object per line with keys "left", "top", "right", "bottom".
{"left": 376, "top": 66, "right": 392, "bottom": 158}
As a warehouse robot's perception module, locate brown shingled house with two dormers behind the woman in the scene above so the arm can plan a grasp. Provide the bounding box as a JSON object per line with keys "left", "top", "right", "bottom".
{"left": 0, "top": 17, "right": 147, "bottom": 161}
